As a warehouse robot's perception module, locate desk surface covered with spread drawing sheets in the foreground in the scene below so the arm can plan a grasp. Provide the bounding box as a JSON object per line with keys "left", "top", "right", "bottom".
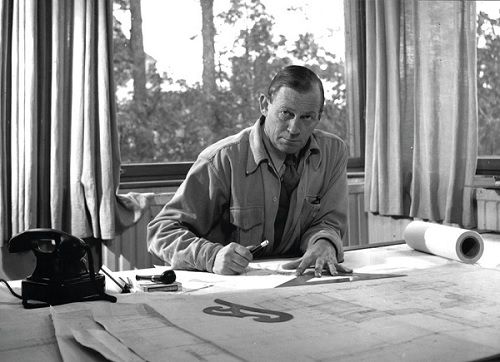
{"left": 0, "top": 245, "right": 500, "bottom": 361}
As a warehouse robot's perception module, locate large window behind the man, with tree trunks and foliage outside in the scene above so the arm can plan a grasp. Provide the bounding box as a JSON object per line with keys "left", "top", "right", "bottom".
{"left": 113, "top": 0, "right": 361, "bottom": 185}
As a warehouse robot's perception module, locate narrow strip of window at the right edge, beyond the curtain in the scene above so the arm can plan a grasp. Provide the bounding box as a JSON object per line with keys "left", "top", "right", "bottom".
{"left": 476, "top": 1, "right": 500, "bottom": 174}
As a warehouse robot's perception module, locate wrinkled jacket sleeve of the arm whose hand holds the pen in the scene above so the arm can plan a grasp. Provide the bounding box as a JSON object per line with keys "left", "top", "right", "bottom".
{"left": 147, "top": 156, "right": 228, "bottom": 272}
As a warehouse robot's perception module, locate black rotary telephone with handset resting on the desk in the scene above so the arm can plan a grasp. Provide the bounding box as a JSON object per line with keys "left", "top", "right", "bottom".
{"left": 9, "top": 229, "right": 116, "bottom": 308}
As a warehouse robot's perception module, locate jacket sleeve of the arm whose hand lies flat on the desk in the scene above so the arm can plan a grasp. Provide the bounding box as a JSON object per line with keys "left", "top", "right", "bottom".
{"left": 301, "top": 142, "right": 348, "bottom": 263}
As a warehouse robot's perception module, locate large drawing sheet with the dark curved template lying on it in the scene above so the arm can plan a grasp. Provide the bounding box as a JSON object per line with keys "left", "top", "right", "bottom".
{"left": 113, "top": 262, "right": 500, "bottom": 361}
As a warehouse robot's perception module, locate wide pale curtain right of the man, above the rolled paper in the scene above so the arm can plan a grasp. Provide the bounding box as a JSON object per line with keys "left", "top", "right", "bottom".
{"left": 365, "top": 0, "right": 477, "bottom": 227}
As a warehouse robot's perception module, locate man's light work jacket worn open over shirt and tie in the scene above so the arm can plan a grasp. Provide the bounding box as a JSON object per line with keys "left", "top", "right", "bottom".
{"left": 147, "top": 117, "right": 348, "bottom": 272}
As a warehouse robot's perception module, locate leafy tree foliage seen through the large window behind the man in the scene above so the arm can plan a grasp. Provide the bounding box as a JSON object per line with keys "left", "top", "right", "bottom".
{"left": 114, "top": 0, "right": 348, "bottom": 163}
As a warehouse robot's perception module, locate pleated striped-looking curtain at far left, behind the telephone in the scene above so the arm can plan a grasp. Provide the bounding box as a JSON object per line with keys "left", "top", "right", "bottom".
{"left": 0, "top": 0, "right": 149, "bottom": 246}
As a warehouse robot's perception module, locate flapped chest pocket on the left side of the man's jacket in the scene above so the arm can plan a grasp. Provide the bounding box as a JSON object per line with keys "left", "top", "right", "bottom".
{"left": 230, "top": 206, "right": 264, "bottom": 246}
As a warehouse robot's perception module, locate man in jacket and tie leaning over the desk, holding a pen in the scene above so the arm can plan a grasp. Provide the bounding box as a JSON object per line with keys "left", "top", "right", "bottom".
{"left": 148, "top": 66, "right": 351, "bottom": 276}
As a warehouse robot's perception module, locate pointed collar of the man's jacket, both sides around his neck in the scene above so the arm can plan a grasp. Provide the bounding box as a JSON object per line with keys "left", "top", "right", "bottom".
{"left": 246, "top": 116, "right": 321, "bottom": 175}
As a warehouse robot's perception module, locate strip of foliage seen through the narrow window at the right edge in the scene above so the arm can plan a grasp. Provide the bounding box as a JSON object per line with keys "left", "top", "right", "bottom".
{"left": 477, "top": 12, "right": 500, "bottom": 156}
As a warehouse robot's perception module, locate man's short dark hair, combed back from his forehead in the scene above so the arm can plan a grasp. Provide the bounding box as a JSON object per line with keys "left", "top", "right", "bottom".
{"left": 267, "top": 65, "right": 325, "bottom": 113}
